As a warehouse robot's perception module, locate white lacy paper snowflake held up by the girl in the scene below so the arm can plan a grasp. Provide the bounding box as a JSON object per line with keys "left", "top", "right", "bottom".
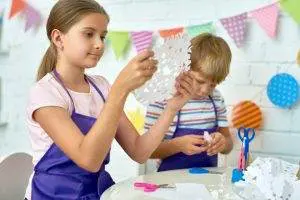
{"left": 134, "top": 34, "right": 190, "bottom": 105}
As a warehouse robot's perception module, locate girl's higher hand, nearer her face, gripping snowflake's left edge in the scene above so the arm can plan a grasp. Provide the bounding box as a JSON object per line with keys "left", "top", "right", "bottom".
{"left": 115, "top": 50, "right": 157, "bottom": 93}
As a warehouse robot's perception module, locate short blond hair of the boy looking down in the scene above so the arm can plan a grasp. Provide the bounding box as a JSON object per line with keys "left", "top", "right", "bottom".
{"left": 191, "top": 33, "right": 231, "bottom": 84}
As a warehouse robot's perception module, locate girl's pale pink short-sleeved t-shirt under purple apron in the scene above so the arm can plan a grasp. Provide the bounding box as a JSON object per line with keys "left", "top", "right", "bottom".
{"left": 25, "top": 73, "right": 110, "bottom": 200}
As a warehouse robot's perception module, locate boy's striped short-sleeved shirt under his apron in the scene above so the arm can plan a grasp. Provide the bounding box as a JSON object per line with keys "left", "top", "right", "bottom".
{"left": 144, "top": 89, "right": 228, "bottom": 139}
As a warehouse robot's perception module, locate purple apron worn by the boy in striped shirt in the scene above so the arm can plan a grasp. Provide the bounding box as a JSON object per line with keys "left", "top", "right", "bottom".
{"left": 157, "top": 96, "right": 218, "bottom": 171}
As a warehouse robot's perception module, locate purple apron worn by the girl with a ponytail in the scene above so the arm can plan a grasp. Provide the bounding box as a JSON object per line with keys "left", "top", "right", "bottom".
{"left": 31, "top": 70, "right": 114, "bottom": 200}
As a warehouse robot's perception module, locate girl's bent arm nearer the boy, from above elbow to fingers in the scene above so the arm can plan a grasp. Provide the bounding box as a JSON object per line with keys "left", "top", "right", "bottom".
{"left": 116, "top": 74, "right": 197, "bottom": 163}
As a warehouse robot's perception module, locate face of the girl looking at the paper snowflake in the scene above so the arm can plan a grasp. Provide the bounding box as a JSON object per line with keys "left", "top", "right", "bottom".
{"left": 61, "top": 13, "right": 108, "bottom": 68}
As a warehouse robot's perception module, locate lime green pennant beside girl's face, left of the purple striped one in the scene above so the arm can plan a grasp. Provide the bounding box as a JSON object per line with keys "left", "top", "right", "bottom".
{"left": 108, "top": 31, "right": 129, "bottom": 59}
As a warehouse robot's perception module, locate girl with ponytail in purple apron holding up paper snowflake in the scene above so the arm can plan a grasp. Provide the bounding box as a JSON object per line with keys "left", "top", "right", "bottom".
{"left": 26, "top": 0, "right": 192, "bottom": 200}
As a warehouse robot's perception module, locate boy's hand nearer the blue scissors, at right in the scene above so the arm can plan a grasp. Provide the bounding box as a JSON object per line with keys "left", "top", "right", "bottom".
{"left": 207, "top": 132, "right": 226, "bottom": 156}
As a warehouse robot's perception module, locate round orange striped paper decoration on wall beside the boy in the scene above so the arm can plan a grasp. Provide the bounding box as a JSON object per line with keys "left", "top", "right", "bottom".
{"left": 231, "top": 101, "right": 262, "bottom": 129}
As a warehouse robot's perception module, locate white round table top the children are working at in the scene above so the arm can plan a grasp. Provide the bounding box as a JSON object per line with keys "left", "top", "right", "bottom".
{"left": 101, "top": 168, "right": 241, "bottom": 200}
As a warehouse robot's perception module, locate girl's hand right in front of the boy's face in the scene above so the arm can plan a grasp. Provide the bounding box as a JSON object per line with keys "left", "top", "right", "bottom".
{"left": 167, "top": 72, "right": 194, "bottom": 112}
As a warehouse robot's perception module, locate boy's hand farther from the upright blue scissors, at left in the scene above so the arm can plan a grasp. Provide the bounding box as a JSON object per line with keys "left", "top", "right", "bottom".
{"left": 174, "top": 135, "right": 208, "bottom": 155}
